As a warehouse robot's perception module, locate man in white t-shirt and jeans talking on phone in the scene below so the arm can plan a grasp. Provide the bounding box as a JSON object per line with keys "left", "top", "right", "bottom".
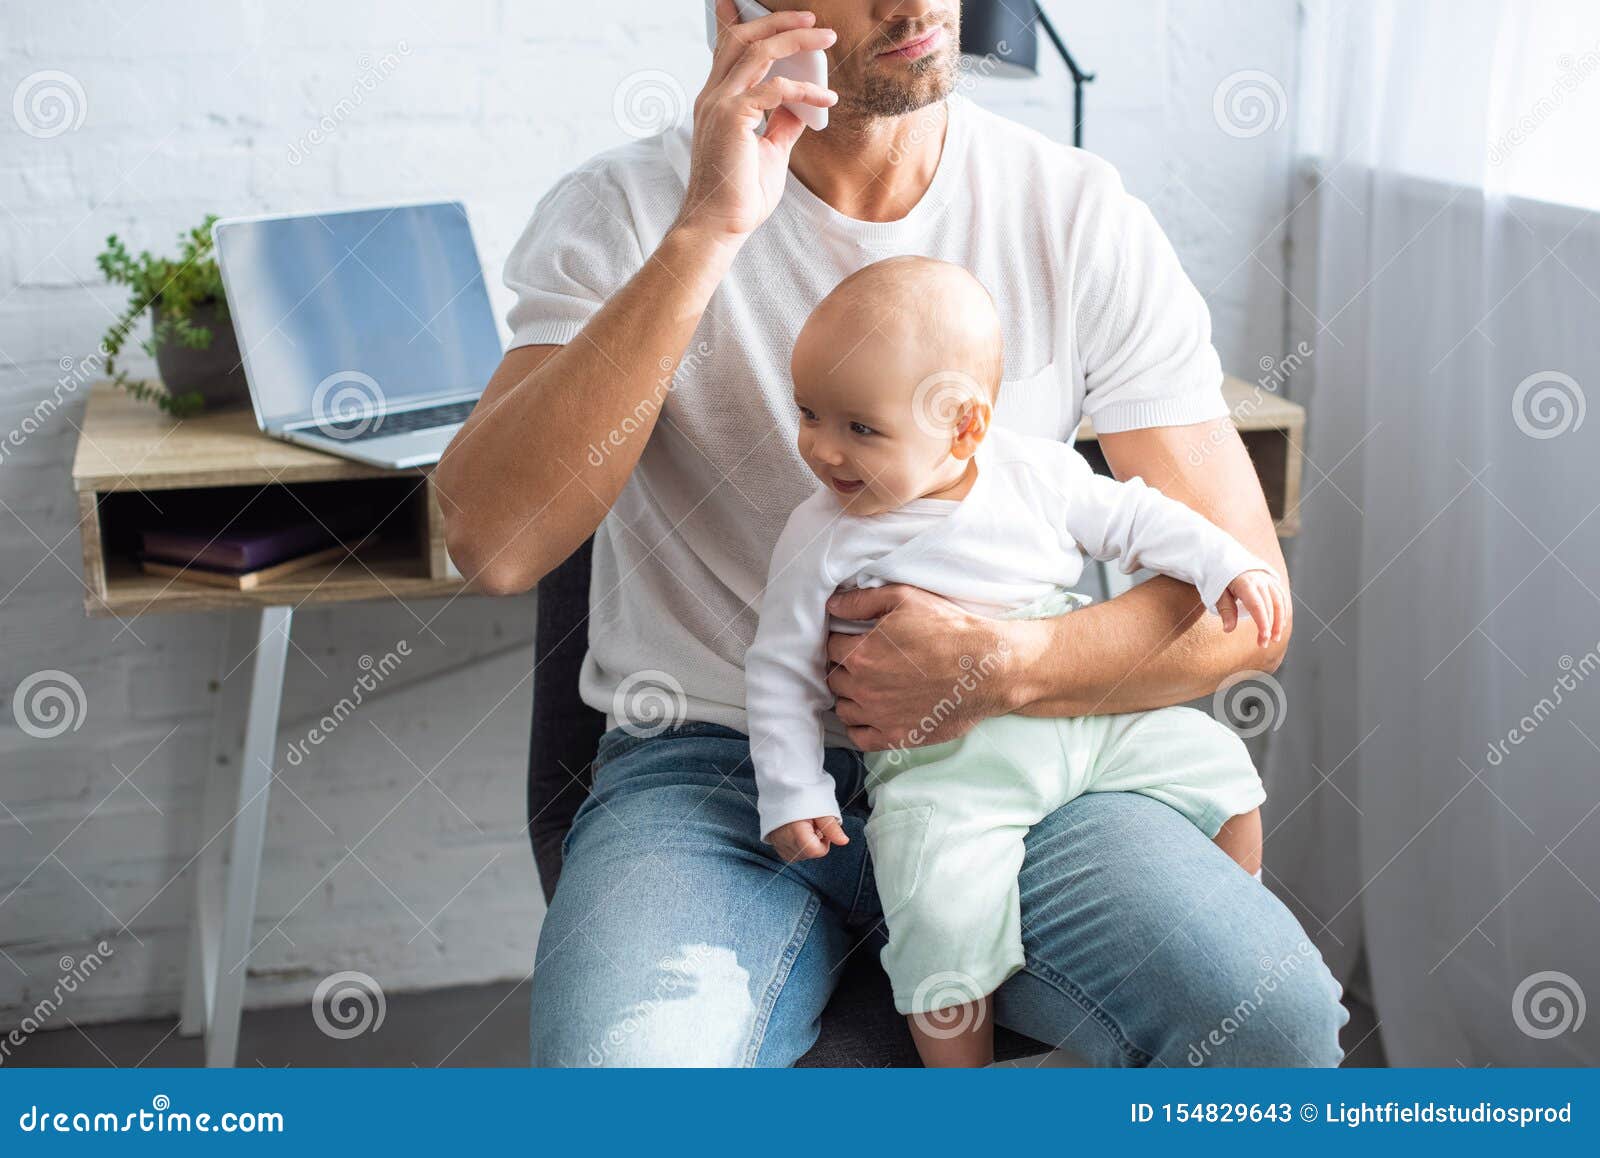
{"left": 437, "top": 0, "right": 1346, "bottom": 1065}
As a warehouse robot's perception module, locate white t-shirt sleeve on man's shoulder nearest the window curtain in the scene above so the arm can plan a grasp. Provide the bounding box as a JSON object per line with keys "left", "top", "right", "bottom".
{"left": 1075, "top": 168, "right": 1229, "bottom": 433}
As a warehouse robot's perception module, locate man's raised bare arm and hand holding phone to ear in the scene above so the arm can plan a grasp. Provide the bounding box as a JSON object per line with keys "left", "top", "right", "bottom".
{"left": 434, "top": 0, "right": 837, "bottom": 595}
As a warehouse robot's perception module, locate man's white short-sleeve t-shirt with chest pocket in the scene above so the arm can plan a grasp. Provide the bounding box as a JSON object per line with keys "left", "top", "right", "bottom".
{"left": 506, "top": 93, "right": 1227, "bottom": 745}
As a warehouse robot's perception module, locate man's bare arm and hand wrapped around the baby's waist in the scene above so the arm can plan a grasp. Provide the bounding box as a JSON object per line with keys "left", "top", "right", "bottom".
{"left": 829, "top": 417, "right": 1293, "bottom": 750}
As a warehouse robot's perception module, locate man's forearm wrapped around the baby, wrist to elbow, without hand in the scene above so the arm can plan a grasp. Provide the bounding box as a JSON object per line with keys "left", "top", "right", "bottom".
{"left": 1005, "top": 576, "right": 1286, "bottom": 717}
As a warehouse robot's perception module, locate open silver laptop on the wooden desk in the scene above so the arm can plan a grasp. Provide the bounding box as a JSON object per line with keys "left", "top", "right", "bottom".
{"left": 211, "top": 202, "right": 502, "bottom": 469}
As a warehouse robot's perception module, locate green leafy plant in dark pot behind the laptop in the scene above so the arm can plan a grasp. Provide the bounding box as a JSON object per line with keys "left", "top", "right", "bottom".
{"left": 96, "top": 214, "right": 250, "bottom": 417}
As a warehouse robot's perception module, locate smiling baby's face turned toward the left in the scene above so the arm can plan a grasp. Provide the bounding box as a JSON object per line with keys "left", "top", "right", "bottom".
{"left": 795, "top": 373, "right": 966, "bottom": 515}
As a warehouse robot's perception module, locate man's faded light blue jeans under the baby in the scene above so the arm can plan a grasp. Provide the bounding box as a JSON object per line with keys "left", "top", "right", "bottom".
{"left": 533, "top": 723, "right": 1347, "bottom": 1065}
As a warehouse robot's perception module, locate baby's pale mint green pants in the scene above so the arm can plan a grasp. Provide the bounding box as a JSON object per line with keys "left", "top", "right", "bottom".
{"left": 866, "top": 592, "right": 1266, "bottom": 1014}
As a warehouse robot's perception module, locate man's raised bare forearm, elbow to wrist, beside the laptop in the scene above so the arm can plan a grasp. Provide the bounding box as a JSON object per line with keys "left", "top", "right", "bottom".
{"left": 435, "top": 229, "right": 733, "bottom": 593}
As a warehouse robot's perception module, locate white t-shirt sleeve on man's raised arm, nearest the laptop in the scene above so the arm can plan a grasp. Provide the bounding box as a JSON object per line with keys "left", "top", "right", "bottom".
{"left": 504, "top": 163, "right": 645, "bottom": 345}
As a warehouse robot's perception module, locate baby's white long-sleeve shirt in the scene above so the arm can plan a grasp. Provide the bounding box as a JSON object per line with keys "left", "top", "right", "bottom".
{"left": 744, "top": 427, "right": 1272, "bottom": 837}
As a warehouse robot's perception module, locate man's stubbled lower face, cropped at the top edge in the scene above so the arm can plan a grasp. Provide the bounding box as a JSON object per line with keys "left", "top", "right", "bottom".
{"left": 787, "top": 0, "right": 962, "bottom": 118}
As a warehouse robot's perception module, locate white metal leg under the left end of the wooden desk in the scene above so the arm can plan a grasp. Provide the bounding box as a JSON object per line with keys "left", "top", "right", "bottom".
{"left": 181, "top": 608, "right": 293, "bottom": 1067}
